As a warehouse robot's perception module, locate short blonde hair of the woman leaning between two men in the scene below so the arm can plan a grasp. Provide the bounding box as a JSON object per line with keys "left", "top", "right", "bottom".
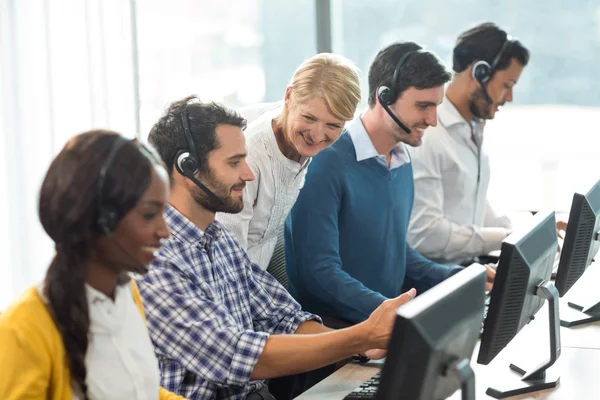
{"left": 282, "top": 53, "right": 360, "bottom": 121}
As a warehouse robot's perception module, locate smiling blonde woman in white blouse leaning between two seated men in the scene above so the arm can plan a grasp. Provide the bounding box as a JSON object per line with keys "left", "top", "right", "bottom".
{"left": 217, "top": 53, "right": 360, "bottom": 269}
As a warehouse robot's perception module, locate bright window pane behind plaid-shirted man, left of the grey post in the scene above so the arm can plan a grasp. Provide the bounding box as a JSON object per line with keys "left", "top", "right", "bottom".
{"left": 138, "top": 0, "right": 316, "bottom": 137}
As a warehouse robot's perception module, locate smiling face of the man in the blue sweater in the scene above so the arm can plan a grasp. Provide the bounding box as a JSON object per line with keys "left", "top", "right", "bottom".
{"left": 384, "top": 85, "right": 444, "bottom": 147}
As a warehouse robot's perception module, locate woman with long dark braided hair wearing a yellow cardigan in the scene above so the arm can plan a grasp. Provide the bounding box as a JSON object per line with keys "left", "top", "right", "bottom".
{"left": 0, "top": 131, "right": 181, "bottom": 400}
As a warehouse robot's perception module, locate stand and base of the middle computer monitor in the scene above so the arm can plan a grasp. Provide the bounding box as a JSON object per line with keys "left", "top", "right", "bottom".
{"left": 485, "top": 281, "right": 560, "bottom": 399}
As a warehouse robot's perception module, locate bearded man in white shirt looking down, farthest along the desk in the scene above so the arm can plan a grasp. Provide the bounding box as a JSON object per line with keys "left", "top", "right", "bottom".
{"left": 408, "top": 23, "right": 529, "bottom": 263}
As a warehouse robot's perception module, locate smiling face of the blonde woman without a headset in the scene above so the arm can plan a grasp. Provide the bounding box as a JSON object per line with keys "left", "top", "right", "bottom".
{"left": 283, "top": 87, "right": 346, "bottom": 157}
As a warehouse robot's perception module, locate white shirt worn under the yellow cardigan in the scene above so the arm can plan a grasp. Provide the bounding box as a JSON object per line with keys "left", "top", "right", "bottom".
{"left": 79, "top": 284, "right": 160, "bottom": 400}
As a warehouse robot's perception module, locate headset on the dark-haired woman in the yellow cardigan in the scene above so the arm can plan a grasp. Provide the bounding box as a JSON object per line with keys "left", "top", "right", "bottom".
{"left": 96, "top": 136, "right": 149, "bottom": 273}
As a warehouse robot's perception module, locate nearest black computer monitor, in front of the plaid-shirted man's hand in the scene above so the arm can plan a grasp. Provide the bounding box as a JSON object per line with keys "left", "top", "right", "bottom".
{"left": 376, "top": 265, "right": 487, "bottom": 400}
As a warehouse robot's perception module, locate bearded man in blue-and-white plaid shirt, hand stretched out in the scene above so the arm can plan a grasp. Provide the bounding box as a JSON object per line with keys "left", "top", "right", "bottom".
{"left": 138, "top": 96, "right": 415, "bottom": 400}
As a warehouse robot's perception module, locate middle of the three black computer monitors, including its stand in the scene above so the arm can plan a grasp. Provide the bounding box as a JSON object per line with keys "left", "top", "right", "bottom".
{"left": 477, "top": 212, "right": 560, "bottom": 399}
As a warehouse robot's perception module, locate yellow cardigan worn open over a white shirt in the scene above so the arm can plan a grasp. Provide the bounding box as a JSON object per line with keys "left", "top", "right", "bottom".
{"left": 0, "top": 280, "right": 184, "bottom": 400}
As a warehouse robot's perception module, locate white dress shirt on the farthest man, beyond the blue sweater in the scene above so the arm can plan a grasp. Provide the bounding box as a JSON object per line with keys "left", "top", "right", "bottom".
{"left": 408, "top": 97, "right": 512, "bottom": 262}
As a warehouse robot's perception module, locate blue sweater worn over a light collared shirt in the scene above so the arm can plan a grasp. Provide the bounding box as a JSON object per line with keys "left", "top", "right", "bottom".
{"left": 285, "top": 131, "right": 460, "bottom": 322}
